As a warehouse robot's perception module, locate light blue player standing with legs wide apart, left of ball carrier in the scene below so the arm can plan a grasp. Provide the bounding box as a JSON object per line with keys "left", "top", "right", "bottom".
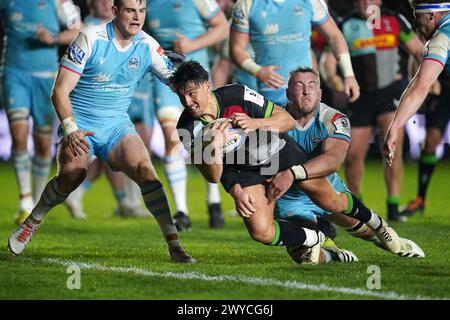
{"left": 8, "top": 0, "right": 194, "bottom": 263}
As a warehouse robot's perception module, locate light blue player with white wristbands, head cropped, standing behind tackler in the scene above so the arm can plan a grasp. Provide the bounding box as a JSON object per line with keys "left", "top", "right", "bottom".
{"left": 230, "top": 0, "right": 359, "bottom": 105}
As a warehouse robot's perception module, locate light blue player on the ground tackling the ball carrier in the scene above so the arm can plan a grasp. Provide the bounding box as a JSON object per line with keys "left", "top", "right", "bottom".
{"left": 266, "top": 67, "right": 424, "bottom": 262}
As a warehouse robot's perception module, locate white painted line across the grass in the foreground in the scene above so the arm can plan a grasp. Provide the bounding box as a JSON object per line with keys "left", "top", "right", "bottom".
{"left": 41, "top": 258, "right": 449, "bottom": 300}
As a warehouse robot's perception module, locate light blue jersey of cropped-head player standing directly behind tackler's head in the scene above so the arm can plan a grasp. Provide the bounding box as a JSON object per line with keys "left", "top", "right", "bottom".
{"left": 231, "top": 0, "right": 330, "bottom": 89}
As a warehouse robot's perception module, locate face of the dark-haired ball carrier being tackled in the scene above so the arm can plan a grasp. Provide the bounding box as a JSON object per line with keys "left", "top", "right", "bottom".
{"left": 178, "top": 81, "right": 210, "bottom": 118}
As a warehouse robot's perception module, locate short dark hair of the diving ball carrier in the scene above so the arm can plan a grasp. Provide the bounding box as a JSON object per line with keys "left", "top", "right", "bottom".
{"left": 169, "top": 60, "right": 209, "bottom": 93}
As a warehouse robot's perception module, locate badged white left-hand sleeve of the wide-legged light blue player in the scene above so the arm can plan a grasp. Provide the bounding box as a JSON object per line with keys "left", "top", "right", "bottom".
{"left": 61, "top": 31, "right": 93, "bottom": 74}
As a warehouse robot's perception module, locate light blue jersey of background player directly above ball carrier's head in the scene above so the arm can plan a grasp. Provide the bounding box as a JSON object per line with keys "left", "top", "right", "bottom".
{"left": 146, "top": 0, "right": 221, "bottom": 66}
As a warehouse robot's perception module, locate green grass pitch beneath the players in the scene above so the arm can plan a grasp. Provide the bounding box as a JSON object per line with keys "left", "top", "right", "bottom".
{"left": 0, "top": 161, "right": 450, "bottom": 300}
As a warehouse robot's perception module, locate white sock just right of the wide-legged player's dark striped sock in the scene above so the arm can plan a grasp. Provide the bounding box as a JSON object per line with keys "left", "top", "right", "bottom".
{"left": 164, "top": 156, "right": 189, "bottom": 214}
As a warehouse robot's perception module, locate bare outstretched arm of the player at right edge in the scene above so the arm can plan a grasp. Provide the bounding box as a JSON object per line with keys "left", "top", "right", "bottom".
{"left": 384, "top": 60, "right": 444, "bottom": 165}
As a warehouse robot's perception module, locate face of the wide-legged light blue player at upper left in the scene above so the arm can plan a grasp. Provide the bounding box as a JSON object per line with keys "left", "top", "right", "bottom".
{"left": 113, "top": 0, "right": 146, "bottom": 38}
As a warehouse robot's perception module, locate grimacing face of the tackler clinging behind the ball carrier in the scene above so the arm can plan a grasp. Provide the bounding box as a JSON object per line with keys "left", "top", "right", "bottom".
{"left": 287, "top": 72, "right": 322, "bottom": 114}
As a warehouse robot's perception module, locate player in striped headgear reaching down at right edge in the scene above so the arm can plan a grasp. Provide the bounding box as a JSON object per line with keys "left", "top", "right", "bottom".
{"left": 384, "top": 0, "right": 450, "bottom": 165}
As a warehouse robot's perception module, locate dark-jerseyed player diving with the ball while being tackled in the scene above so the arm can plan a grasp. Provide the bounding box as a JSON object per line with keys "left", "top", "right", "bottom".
{"left": 170, "top": 61, "right": 400, "bottom": 263}
